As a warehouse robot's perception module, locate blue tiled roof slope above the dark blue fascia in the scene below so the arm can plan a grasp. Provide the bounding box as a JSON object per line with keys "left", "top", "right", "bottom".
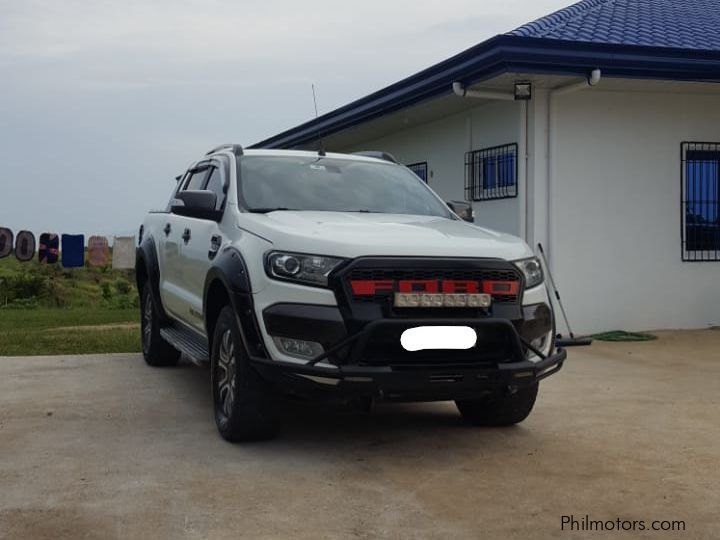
{"left": 509, "top": 0, "right": 720, "bottom": 51}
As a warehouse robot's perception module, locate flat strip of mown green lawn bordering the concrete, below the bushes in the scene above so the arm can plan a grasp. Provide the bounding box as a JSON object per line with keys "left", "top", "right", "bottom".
{"left": 0, "top": 308, "right": 141, "bottom": 356}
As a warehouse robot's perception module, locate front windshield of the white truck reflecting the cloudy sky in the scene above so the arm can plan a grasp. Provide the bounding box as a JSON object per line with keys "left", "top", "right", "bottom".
{"left": 238, "top": 156, "right": 451, "bottom": 218}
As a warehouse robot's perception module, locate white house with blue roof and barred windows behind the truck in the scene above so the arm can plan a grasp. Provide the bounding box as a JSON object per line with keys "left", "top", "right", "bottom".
{"left": 254, "top": 0, "right": 720, "bottom": 332}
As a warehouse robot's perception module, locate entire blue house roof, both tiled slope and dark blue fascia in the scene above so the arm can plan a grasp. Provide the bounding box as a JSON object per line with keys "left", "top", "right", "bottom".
{"left": 251, "top": 0, "right": 720, "bottom": 148}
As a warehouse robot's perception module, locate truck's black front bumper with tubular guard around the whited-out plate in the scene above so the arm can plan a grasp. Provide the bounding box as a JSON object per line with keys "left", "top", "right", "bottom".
{"left": 251, "top": 304, "right": 567, "bottom": 401}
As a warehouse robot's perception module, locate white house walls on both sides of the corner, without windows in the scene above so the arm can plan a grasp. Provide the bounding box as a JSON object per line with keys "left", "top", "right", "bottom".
{"left": 343, "top": 87, "right": 720, "bottom": 333}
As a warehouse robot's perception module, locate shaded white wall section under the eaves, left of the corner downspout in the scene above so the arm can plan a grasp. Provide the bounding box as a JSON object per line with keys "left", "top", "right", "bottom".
{"left": 339, "top": 98, "right": 522, "bottom": 235}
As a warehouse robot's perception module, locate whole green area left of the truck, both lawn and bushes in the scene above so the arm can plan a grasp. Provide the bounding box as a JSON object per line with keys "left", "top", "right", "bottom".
{"left": 0, "top": 257, "right": 140, "bottom": 356}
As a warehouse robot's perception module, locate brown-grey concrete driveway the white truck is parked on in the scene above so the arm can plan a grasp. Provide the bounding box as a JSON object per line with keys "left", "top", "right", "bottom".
{"left": 0, "top": 330, "right": 720, "bottom": 540}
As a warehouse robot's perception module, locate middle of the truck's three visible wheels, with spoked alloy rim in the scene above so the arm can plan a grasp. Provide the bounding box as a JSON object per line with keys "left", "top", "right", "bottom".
{"left": 210, "top": 306, "right": 277, "bottom": 442}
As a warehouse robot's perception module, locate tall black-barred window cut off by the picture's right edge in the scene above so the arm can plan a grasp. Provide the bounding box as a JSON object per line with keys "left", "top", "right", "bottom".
{"left": 681, "top": 142, "right": 720, "bottom": 261}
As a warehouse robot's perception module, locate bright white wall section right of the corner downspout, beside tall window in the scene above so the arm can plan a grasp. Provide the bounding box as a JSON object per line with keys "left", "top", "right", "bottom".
{"left": 550, "top": 88, "right": 720, "bottom": 332}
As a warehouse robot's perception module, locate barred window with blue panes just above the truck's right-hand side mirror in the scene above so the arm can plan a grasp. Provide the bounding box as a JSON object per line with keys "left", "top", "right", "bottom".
{"left": 465, "top": 143, "right": 518, "bottom": 201}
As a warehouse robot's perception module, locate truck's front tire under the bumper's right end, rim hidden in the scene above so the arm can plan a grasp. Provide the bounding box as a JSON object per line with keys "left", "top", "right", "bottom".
{"left": 455, "top": 383, "right": 538, "bottom": 426}
